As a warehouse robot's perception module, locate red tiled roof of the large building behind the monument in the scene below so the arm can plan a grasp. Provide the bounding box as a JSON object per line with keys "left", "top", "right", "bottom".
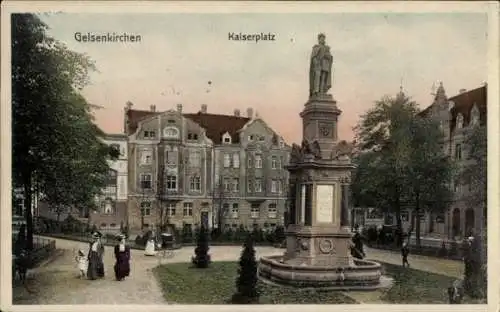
{"left": 126, "top": 109, "right": 250, "bottom": 144}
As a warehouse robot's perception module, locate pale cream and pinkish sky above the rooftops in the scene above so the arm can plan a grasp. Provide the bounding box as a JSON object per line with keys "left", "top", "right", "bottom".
{"left": 41, "top": 13, "right": 488, "bottom": 143}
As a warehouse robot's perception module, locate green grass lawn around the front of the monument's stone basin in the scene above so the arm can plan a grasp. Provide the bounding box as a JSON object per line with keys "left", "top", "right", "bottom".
{"left": 154, "top": 262, "right": 484, "bottom": 304}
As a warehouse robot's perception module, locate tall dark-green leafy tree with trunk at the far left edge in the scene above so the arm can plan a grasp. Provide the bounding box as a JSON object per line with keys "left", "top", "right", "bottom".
{"left": 11, "top": 14, "right": 117, "bottom": 249}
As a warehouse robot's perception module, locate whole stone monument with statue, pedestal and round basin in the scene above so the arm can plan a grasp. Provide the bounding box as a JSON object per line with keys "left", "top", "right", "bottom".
{"left": 259, "top": 34, "right": 381, "bottom": 289}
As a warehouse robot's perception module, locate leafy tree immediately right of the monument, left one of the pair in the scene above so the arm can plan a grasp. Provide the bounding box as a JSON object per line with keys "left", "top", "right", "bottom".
{"left": 353, "top": 93, "right": 418, "bottom": 244}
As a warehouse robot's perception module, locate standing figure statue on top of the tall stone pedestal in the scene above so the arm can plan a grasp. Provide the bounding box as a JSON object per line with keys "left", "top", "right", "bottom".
{"left": 309, "top": 34, "right": 333, "bottom": 96}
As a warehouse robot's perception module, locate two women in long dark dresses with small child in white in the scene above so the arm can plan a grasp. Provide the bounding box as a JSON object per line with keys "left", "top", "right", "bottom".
{"left": 75, "top": 232, "right": 130, "bottom": 281}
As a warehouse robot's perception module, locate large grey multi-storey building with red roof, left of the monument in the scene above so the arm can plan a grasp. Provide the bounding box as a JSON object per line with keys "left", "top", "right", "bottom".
{"left": 124, "top": 103, "right": 289, "bottom": 231}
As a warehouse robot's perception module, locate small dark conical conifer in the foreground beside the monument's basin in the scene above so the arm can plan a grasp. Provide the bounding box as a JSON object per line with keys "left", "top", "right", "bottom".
{"left": 232, "top": 234, "right": 260, "bottom": 304}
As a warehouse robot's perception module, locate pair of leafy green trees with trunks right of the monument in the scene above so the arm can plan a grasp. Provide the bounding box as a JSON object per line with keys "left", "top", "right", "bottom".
{"left": 352, "top": 93, "right": 452, "bottom": 245}
